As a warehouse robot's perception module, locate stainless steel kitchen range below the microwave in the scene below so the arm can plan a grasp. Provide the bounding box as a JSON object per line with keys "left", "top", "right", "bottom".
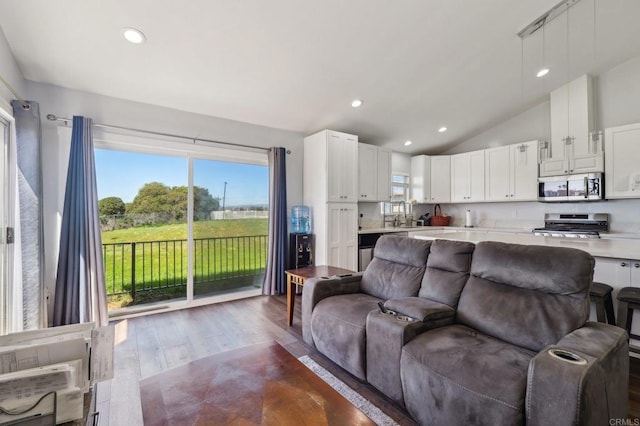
{"left": 531, "top": 213, "right": 609, "bottom": 238}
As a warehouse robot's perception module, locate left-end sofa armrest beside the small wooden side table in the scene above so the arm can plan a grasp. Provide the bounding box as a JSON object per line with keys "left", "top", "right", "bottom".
{"left": 302, "top": 272, "right": 362, "bottom": 346}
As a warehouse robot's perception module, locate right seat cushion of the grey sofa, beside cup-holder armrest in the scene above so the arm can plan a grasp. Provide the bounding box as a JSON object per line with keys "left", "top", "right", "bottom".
{"left": 400, "top": 325, "right": 535, "bottom": 425}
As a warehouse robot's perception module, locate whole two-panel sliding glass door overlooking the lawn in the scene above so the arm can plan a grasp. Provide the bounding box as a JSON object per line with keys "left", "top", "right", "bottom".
{"left": 96, "top": 141, "right": 269, "bottom": 310}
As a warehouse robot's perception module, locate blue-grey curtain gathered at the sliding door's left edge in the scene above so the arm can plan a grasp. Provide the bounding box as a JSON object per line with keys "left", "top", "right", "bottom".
{"left": 53, "top": 116, "right": 108, "bottom": 327}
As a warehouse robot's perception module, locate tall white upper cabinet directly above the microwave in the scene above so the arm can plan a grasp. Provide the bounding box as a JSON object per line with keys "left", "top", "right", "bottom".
{"left": 540, "top": 75, "right": 604, "bottom": 176}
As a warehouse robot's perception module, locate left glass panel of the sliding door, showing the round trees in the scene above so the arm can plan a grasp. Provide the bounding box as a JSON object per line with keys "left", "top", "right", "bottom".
{"left": 95, "top": 149, "right": 189, "bottom": 310}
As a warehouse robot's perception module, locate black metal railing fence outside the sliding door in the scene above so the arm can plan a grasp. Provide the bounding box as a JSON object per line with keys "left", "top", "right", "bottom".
{"left": 102, "top": 235, "right": 267, "bottom": 301}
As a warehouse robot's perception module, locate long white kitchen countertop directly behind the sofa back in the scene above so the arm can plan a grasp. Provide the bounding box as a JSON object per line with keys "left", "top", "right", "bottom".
{"left": 408, "top": 227, "right": 640, "bottom": 260}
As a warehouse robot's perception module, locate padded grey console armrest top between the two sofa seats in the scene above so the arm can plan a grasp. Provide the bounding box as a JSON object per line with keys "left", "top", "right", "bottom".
{"left": 384, "top": 297, "right": 456, "bottom": 322}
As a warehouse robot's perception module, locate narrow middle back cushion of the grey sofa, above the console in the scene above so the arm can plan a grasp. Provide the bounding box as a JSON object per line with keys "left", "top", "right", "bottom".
{"left": 418, "top": 240, "right": 475, "bottom": 308}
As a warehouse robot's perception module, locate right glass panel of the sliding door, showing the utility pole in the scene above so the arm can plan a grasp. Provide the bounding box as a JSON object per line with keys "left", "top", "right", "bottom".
{"left": 193, "top": 159, "right": 269, "bottom": 296}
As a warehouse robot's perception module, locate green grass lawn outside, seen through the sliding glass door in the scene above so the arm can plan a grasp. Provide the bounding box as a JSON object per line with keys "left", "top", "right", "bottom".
{"left": 102, "top": 219, "right": 268, "bottom": 309}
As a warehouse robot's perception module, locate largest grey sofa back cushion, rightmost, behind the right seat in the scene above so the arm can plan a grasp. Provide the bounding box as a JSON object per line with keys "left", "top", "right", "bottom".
{"left": 456, "top": 242, "right": 595, "bottom": 351}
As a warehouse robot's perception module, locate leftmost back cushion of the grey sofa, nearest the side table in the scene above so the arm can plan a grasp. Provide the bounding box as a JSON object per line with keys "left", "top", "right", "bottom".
{"left": 360, "top": 235, "right": 431, "bottom": 300}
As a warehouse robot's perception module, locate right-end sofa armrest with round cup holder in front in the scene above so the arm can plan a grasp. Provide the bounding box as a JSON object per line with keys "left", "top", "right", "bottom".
{"left": 525, "top": 323, "right": 629, "bottom": 425}
